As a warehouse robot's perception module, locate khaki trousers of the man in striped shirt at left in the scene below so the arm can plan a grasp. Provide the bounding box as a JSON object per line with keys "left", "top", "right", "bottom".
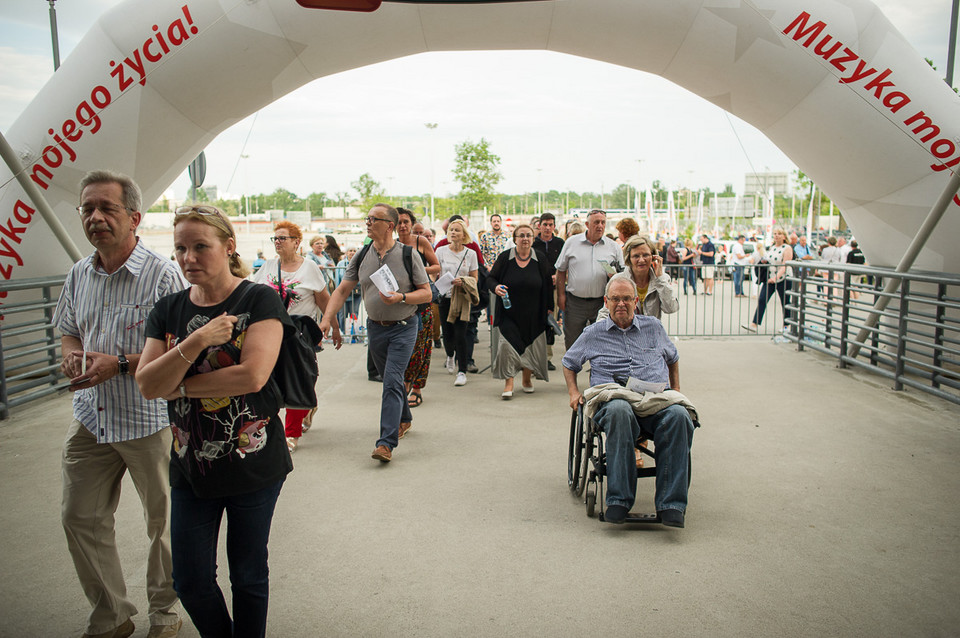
{"left": 61, "top": 419, "right": 179, "bottom": 634}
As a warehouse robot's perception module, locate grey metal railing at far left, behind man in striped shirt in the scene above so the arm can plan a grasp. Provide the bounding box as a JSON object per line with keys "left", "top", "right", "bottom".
{"left": 0, "top": 275, "right": 67, "bottom": 419}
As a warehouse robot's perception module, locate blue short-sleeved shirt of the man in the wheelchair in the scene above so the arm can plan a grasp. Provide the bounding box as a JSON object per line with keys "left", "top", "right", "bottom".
{"left": 563, "top": 315, "right": 680, "bottom": 386}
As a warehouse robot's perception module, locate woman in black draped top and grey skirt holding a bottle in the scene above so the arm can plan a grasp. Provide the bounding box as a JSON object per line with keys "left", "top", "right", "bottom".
{"left": 487, "top": 224, "right": 553, "bottom": 399}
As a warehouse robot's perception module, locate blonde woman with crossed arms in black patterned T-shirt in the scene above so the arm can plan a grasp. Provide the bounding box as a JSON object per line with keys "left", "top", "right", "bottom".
{"left": 136, "top": 206, "right": 293, "bottom": 636}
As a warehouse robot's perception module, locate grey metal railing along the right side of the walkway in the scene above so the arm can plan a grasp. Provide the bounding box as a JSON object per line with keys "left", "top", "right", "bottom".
{"left": 784, "top": 262, "right": 960, "bottom": 403}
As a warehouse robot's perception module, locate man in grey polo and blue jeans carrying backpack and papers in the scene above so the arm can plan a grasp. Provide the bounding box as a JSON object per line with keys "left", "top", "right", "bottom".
{"left": 320, "top": 204, "right": 433, "bottom": 463}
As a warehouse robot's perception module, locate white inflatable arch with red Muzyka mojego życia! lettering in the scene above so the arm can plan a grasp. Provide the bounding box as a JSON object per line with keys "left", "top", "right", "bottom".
{"left": 0, "top": 0, "right": 960, "bottom": 296}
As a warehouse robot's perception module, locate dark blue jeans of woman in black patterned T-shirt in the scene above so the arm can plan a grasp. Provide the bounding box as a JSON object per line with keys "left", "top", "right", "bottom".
{"left": 170, "top": 481, "right": 283, "bottom": 638}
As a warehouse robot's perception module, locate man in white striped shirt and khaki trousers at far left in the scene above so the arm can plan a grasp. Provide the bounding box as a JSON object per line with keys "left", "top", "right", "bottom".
{"left": 54, "top": 171, "right": 183, "bottom": 638}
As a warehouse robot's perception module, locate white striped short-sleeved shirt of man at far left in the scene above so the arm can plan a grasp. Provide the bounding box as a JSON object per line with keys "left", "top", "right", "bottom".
{"left": 53, "top": 241, "right": 184, "bottom": 443}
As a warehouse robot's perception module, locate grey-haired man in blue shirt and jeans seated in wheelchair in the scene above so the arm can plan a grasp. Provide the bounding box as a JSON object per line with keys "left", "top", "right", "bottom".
{"left": 563, "top": 275, "right": 694, "bottom": 527}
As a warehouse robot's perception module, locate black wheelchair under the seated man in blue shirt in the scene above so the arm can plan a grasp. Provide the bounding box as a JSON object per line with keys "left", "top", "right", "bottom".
{"left": 567, "top": 405, "right": 660, "bottom": 523}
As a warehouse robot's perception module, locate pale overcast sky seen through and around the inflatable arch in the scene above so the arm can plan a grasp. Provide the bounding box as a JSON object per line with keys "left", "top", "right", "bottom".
{"left": 0, "top": 0, "right": 950, "bottom": 197}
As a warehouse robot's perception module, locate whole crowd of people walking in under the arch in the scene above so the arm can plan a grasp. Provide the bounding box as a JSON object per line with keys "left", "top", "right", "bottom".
{"left": 54, "top": 171, "right": 862, "bottom": 638}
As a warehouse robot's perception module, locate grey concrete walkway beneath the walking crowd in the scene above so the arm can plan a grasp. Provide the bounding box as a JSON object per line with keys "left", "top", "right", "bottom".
{"left": 0, "top": 338, "right": 960, "bottom": 638}
